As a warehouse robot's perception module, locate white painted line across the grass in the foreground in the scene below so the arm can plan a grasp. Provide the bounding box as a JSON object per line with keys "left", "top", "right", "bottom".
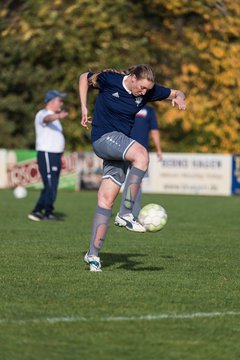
{"left": 0, "top": 311, "right": 240, "bottom": 325}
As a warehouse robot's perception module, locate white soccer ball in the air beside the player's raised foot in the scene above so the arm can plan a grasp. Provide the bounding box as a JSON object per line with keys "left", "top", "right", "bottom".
{"left": 138, "top": 204, "right": 168, "bottom": 232}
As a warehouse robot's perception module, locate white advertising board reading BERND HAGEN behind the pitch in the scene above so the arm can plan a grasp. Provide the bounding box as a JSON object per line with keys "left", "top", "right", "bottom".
{"left": 142, "top": 153, "right": 232, "bottom": 195}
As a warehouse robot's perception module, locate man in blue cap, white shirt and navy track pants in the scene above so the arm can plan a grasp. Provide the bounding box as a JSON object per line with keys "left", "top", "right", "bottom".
{"left": 28, "top": 90, "right": 68, "bottom": 221}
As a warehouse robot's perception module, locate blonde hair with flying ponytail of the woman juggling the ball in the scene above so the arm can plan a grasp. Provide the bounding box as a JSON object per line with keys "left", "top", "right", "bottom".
{"left": 88, "top": 64, "right": 155, "bottom": 87}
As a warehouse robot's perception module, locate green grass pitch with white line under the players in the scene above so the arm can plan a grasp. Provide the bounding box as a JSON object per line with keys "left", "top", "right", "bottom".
{"left": 0, "top": 191, "right": 240, "bottom": 360}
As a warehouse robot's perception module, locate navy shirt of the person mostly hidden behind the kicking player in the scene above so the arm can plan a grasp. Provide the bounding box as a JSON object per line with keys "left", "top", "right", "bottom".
{"left": 130, "top": 105, "right": 159, "bottom": 150}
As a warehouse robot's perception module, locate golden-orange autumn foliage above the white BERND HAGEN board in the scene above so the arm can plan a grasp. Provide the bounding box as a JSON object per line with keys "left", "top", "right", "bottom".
{"left": 148, "top": 0, "right": 240, "bottom": 153}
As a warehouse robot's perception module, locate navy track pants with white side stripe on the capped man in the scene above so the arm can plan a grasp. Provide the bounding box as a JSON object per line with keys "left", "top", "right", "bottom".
{"left": 33, "top": 151, "right": 62, "bottom": 215}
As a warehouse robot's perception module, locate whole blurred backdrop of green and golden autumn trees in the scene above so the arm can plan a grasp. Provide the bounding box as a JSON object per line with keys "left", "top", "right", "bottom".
{"left": 0, "top": 0, "right": 240, "bottom": 153}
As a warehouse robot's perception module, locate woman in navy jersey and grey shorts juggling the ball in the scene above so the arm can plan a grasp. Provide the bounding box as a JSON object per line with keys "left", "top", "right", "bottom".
{"left": 79, "top": 64, "right": 186, "bottom": 272}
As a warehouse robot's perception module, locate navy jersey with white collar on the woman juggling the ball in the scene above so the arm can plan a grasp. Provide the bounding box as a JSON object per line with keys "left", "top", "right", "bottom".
{"left": 88, "top": 72, "right": 171, "bottom": 142}
